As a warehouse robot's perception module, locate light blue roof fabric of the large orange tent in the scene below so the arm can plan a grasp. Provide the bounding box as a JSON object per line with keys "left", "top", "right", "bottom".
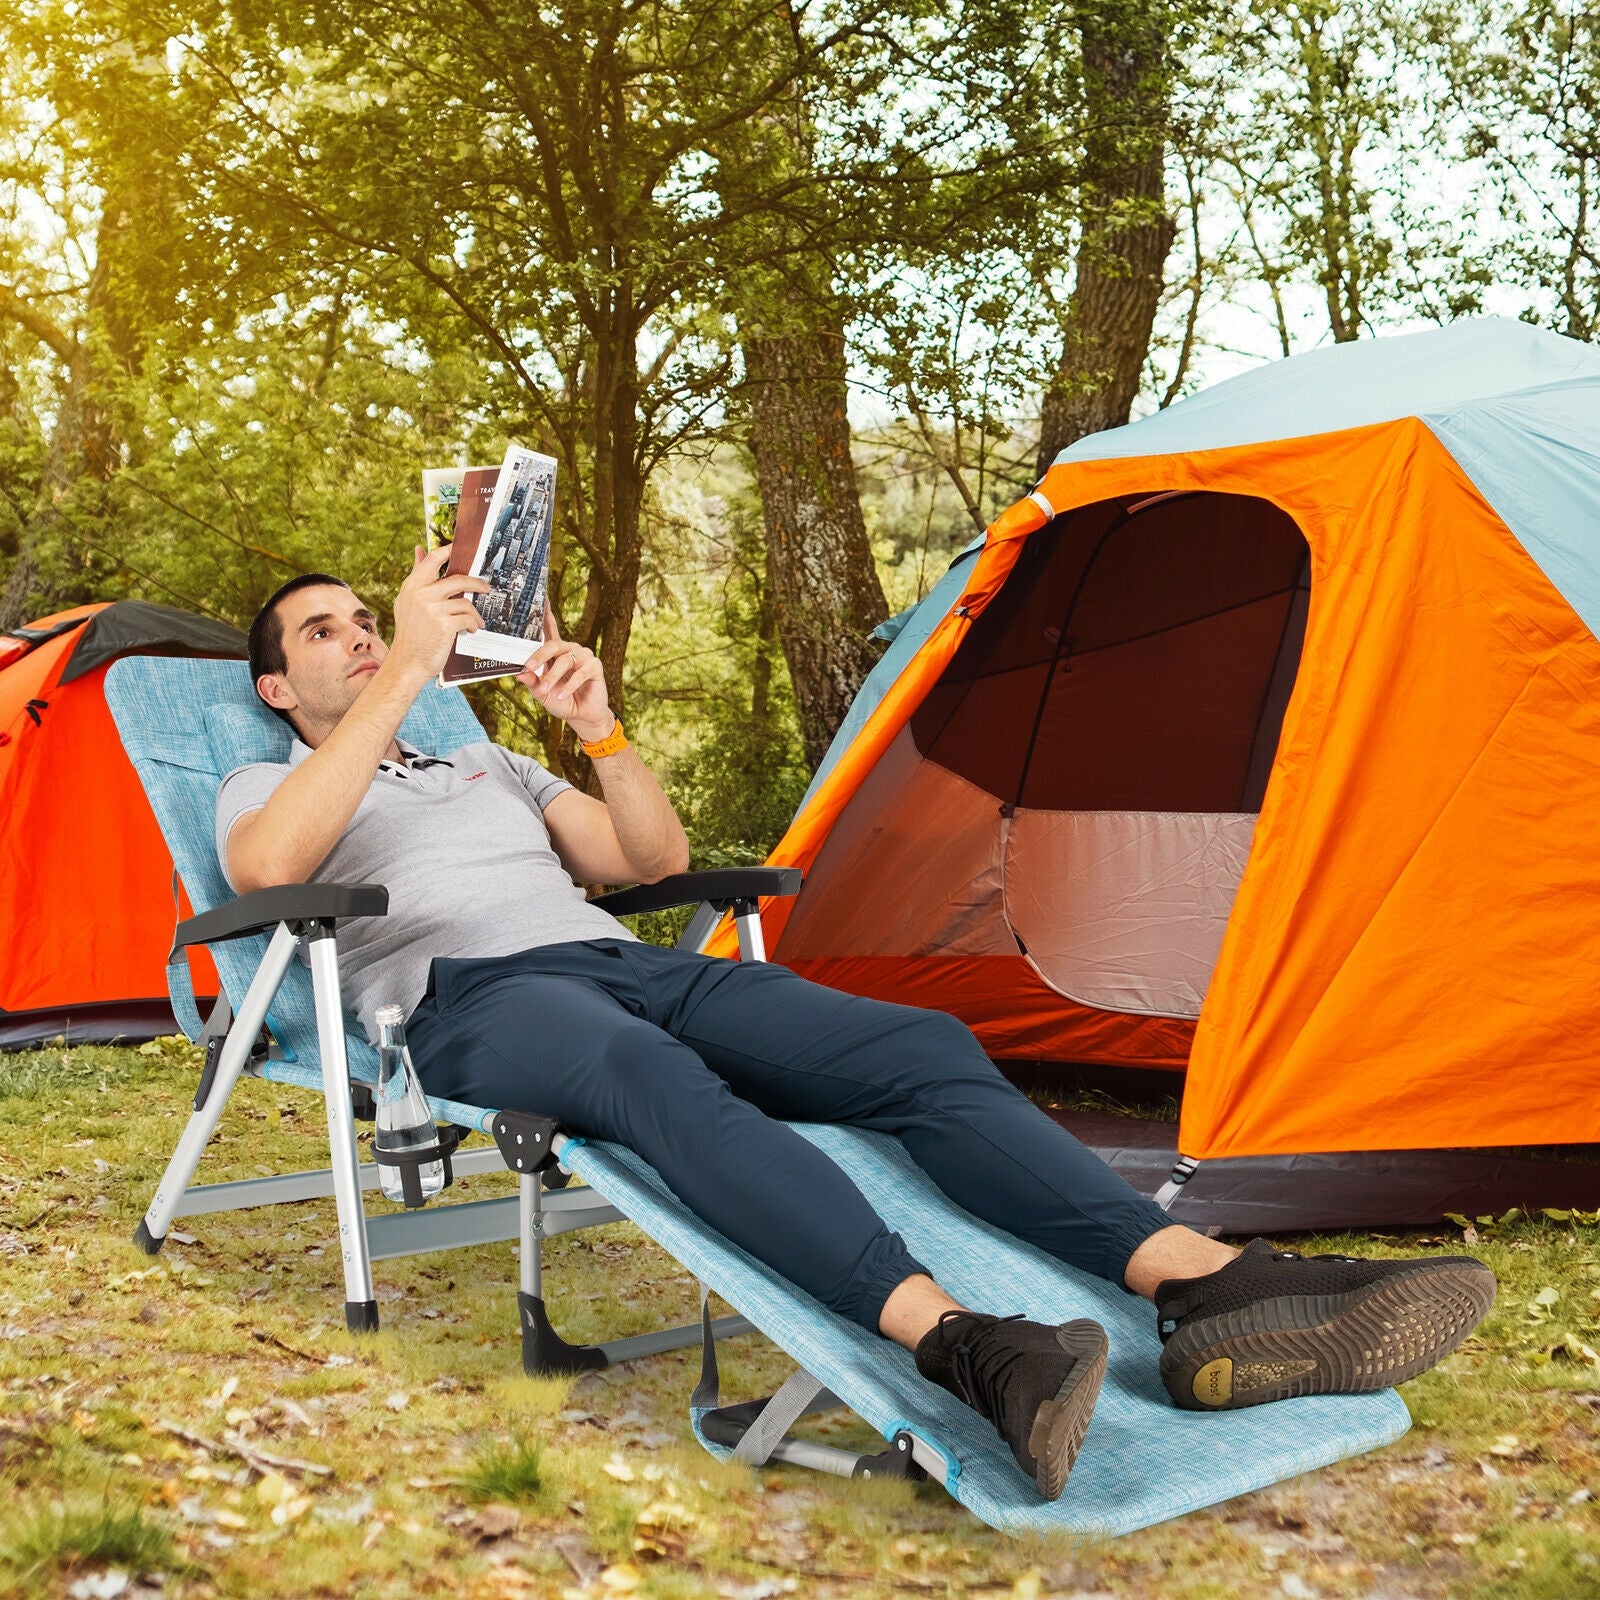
{"left": 800, "top": 317, "right": 1600, "bottom": 810}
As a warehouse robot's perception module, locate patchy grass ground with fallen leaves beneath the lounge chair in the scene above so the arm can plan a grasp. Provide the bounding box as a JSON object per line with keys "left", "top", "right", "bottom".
{"left": 0, "top": 1045, "right": 1600, "bottom": 1600}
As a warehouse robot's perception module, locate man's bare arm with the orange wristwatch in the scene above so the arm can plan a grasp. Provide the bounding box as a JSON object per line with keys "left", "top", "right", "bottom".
{"left": 517, "top": 605, "right": 690, "bottom": 883}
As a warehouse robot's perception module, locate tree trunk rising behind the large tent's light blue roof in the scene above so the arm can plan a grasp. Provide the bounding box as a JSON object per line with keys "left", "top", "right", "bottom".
{"left": 1038, "top": 8, "right": 1178, "bottom": 477}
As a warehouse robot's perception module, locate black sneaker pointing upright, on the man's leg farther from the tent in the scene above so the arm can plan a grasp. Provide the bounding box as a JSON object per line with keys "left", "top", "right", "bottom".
{"left": 917, "top": 1310, "right": 1106, "bottom": 1499}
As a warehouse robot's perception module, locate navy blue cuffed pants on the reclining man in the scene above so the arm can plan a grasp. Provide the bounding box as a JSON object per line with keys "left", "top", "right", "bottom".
{"left": 406, "top": 939, "right": 1171, "bottom": 1333}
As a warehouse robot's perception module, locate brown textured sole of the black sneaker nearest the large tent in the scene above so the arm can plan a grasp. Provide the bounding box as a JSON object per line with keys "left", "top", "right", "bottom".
{"left": 1162, "top": 1266, "right": 1494, "bottom": 1411}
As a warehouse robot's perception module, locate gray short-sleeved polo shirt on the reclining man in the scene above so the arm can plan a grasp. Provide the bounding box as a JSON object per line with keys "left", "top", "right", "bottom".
{"left": 216, "top": 739, "right": 634, "bottom": 1040}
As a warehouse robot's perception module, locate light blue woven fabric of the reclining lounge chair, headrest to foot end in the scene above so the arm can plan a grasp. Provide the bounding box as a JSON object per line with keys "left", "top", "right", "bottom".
{"left": 106, "top": 658, "right": 1410, "bottom": 1534}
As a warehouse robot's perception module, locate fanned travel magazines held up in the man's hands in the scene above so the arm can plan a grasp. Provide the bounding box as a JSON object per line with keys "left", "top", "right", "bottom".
{"left": 422, "top": 445, "right": 557, "bottom": 683}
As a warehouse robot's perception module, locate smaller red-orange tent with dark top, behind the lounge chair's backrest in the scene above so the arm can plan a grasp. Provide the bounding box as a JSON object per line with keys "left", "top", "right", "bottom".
{"left": 0, "top": 600, "right": 245, "bottom": 1050}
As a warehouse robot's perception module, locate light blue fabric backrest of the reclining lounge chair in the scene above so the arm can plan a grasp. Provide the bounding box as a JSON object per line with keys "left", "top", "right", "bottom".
{"left": 106, "top": 656, "right": 483, "bottom": 1078}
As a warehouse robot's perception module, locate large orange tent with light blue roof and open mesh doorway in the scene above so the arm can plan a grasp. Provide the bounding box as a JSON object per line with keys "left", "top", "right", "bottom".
{"left": 709, "top": 318, "right": 1600, "bottom": 1160}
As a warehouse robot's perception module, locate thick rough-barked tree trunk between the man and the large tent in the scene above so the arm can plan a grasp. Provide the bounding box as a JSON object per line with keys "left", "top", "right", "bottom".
{"left": 742, "top": 293, "right": 888, "bottom": 770}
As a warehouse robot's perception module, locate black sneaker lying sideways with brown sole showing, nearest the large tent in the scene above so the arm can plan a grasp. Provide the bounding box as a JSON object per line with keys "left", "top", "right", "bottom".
{"left": 1155, "top": 1238, "right": 1494, "bottom": 1411}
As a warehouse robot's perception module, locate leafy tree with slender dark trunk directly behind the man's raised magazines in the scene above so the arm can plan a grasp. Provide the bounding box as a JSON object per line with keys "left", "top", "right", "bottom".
{"left": 136, "top": 0, "right": 928, "bottom": 780}
